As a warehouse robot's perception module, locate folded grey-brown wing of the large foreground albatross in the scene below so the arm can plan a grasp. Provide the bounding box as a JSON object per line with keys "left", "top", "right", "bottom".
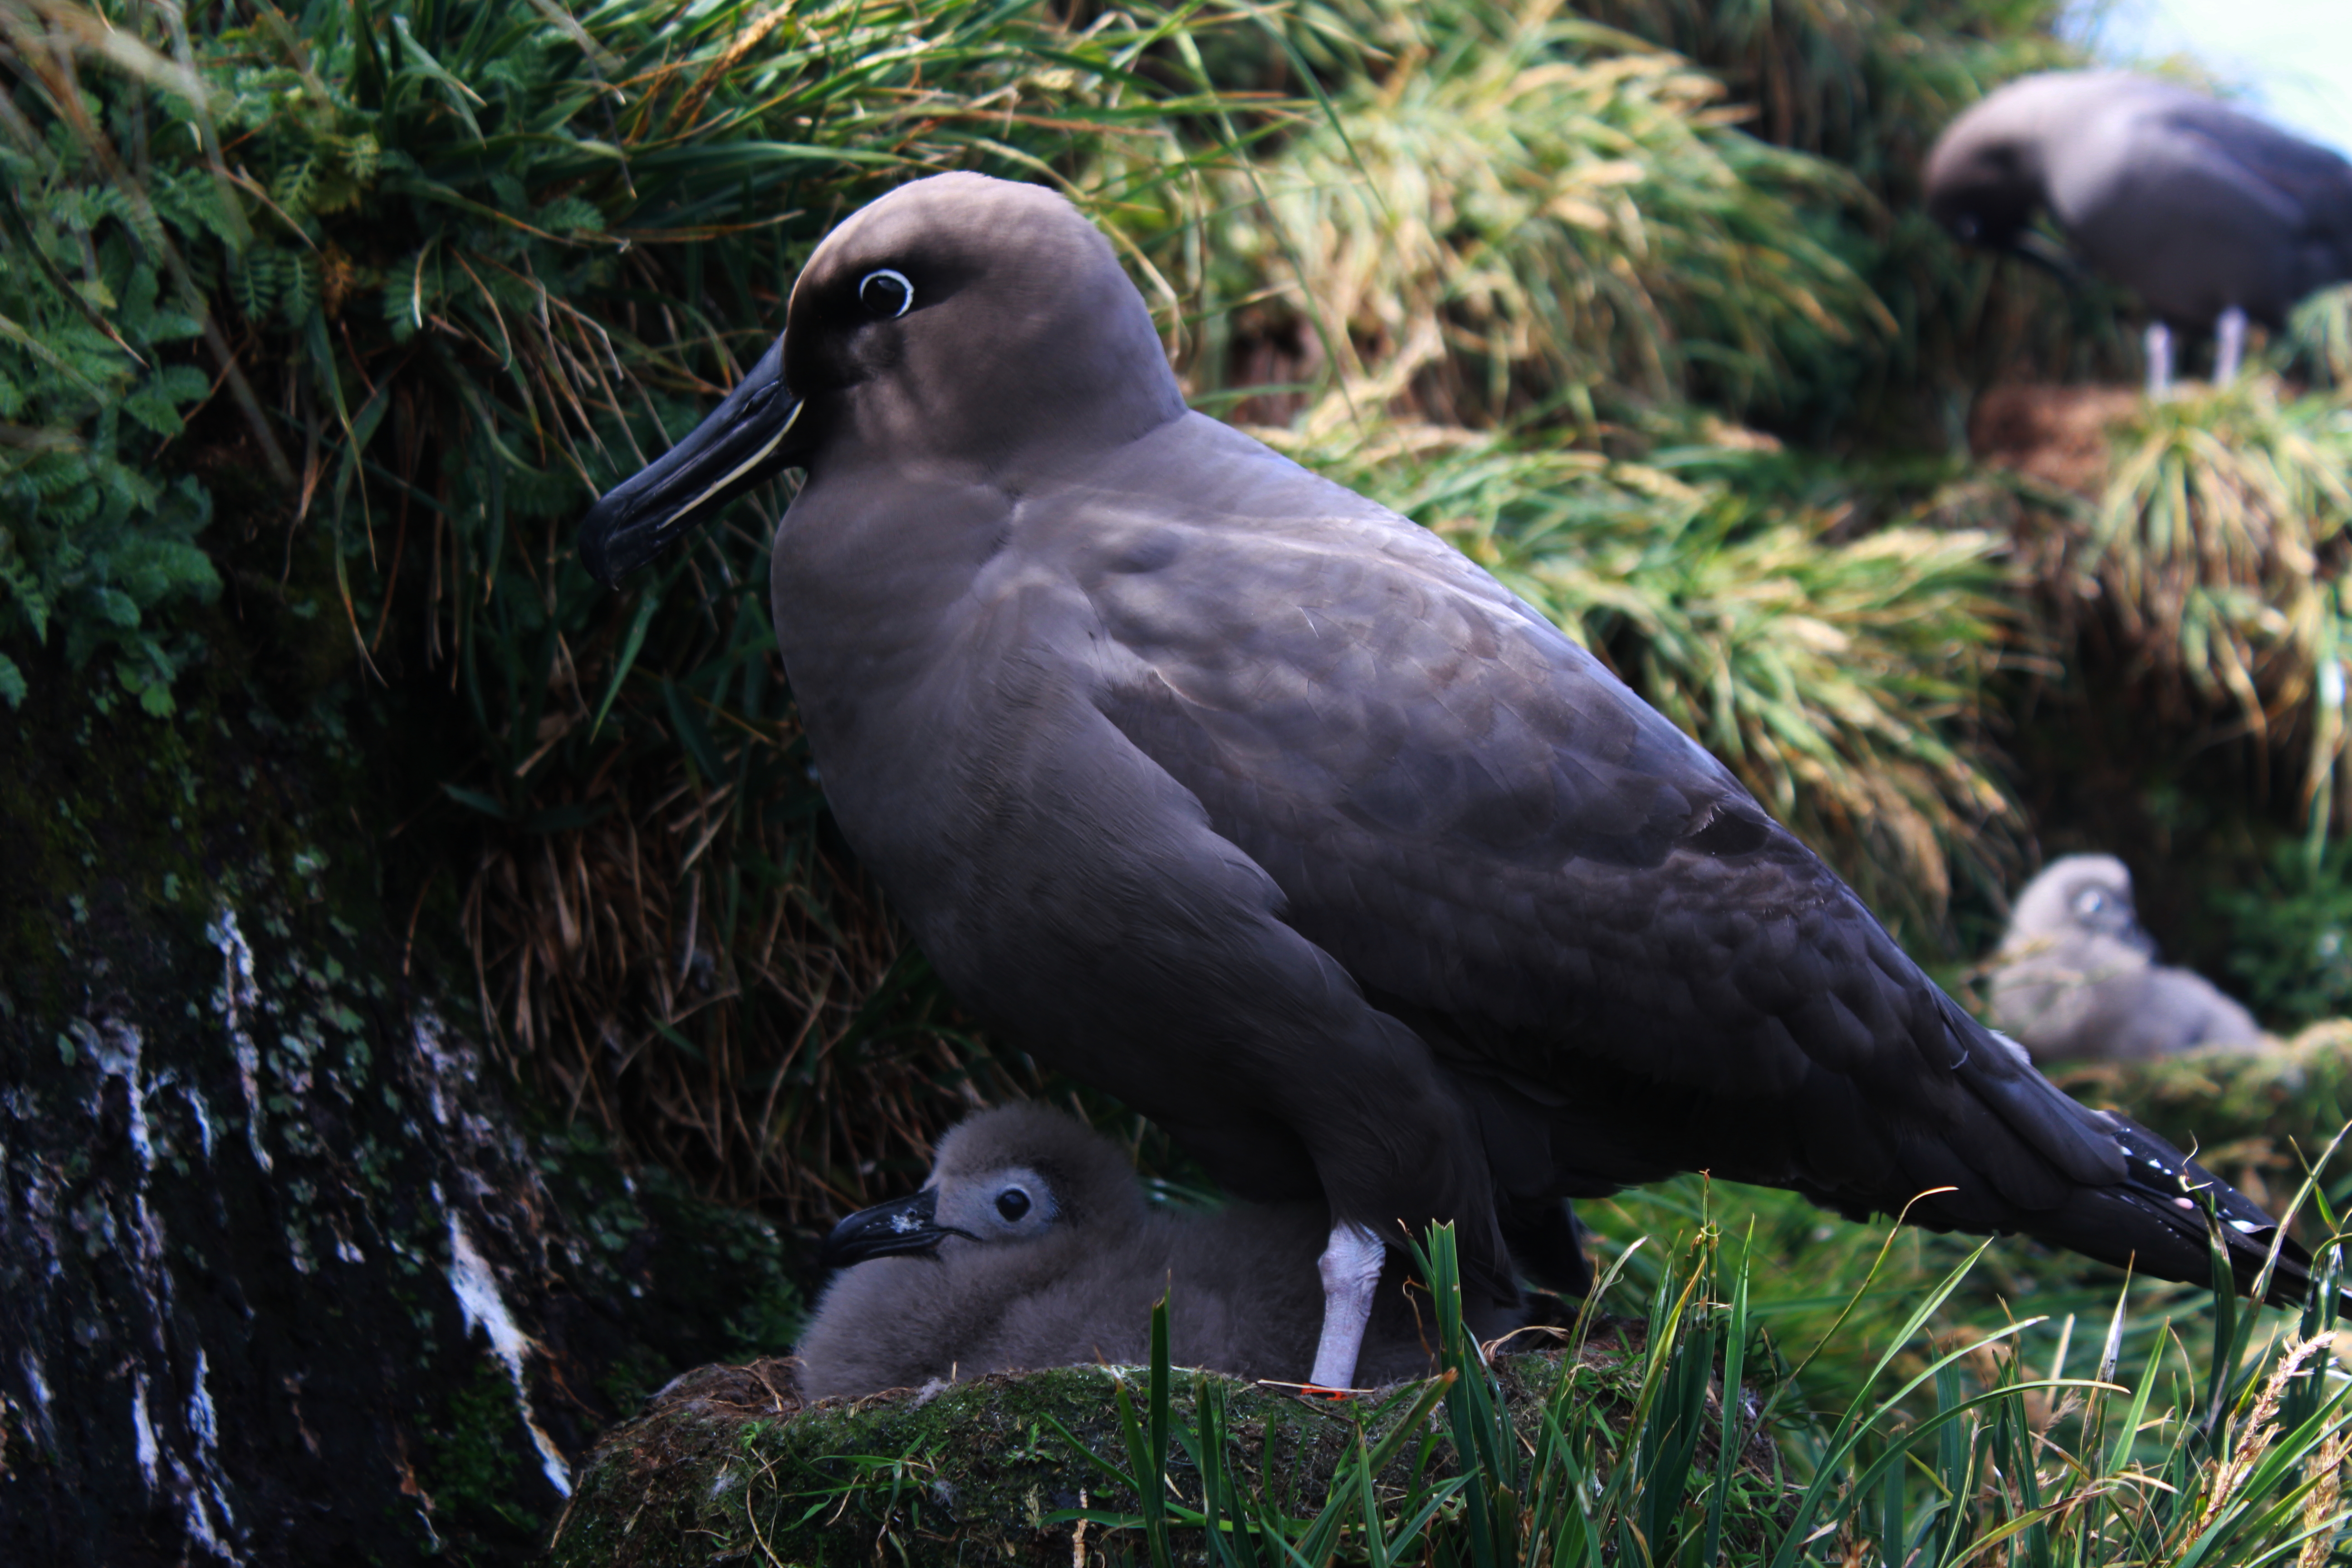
{"left": 1073, "top": 432, "right": 2119, "bottom": 1222}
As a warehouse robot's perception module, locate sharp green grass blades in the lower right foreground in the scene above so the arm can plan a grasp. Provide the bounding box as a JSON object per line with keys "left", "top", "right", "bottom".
{"left": 1068, "top": 1225, "right": 2352, "bottom": 1568}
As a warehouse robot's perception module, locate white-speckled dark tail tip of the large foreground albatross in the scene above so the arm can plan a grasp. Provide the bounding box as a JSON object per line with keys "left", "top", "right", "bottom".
{"left": 2030, "top": 1110, "right": 2352, "bottom": 1317}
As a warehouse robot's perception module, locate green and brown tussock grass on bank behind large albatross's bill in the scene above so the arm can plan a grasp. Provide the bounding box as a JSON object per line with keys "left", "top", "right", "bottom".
{"left": 0, "top": 0, "right": 1268, "bottom": 1220}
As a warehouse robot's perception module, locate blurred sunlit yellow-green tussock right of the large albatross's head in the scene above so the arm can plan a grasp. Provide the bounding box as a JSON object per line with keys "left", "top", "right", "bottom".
{"left": 1216, "top": 2, "right": 1893, "bottom": 426}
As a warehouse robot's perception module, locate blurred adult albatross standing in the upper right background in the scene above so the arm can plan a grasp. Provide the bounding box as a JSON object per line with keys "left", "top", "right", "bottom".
{"left": 1926, "top": 70, "right": 2352, "bottom": 397}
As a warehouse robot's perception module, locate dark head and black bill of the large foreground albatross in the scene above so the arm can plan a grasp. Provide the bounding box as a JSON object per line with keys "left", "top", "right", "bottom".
{"left": 578, "top": 174, "right": 1186, "bottom": 585}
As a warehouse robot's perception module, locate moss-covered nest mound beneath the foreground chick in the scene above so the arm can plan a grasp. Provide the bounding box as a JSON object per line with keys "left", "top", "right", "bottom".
{"left": 550, "top": 1326, "right": 1783, "bottom": 1568}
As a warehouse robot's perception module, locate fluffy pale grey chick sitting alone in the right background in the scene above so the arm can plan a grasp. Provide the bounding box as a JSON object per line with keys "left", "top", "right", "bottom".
{"left": 1992, "top": 856, "right": 2263, "bottom": 1060}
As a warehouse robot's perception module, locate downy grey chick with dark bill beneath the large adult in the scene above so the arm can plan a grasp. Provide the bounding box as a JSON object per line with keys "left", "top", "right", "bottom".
{"left": 795, "top": 1105, "right": 1519, "bottom": 1399}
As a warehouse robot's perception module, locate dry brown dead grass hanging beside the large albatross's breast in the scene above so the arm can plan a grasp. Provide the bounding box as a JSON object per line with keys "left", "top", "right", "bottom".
{"left": 463, "top": 681, "right": 1077, "bottom": 1225}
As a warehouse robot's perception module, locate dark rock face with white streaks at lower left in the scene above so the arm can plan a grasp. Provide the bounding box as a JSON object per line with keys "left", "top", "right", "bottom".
{"left": 0, "top": 649, "right": 795, "bottom": 1568}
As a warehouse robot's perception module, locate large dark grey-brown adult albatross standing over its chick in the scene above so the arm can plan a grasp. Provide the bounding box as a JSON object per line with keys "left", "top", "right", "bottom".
{"left": 581, "top": 174, "right": 2333, "bottom": 1387}
